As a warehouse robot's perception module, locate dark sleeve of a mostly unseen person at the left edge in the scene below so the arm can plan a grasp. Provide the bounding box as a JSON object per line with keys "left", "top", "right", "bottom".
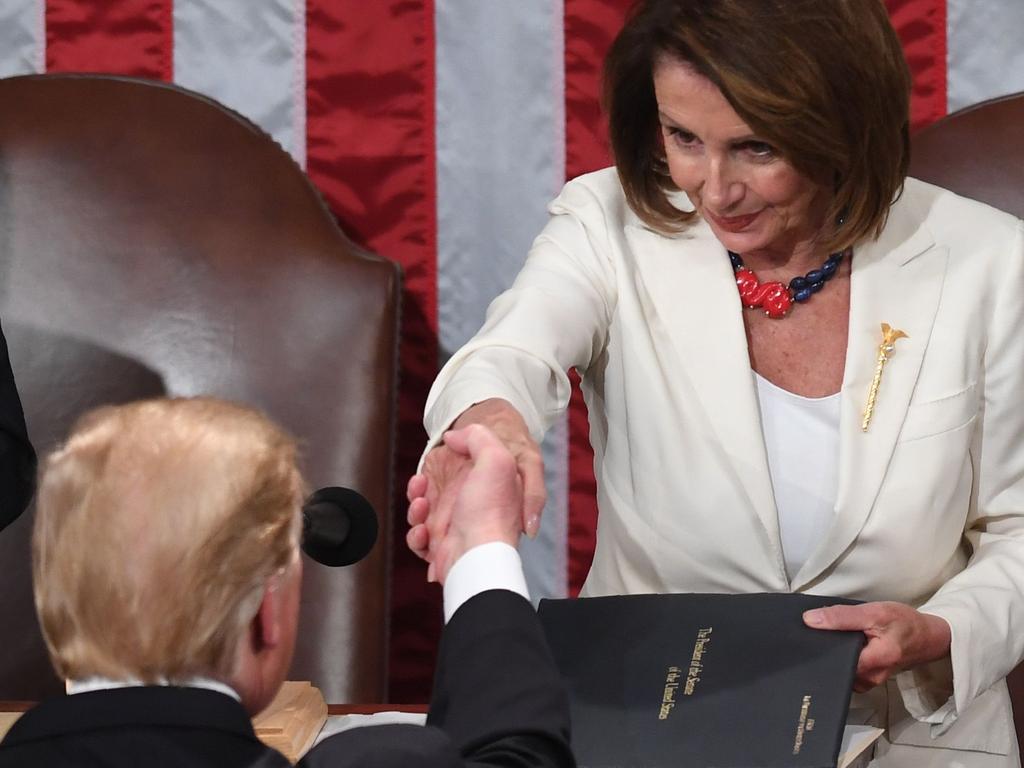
{"left": 0, "top": 321, "right": 36, "bottom": 530}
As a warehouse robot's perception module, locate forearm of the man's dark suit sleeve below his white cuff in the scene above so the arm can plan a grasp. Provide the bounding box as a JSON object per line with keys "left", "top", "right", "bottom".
{"left": 427, "top": 590, "right": 575, "bottom": 768}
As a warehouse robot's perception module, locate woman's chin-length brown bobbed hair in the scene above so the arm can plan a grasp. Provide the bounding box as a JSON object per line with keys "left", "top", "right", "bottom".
{"left": 604, "top": 0, "right": 910, "bottom": 251}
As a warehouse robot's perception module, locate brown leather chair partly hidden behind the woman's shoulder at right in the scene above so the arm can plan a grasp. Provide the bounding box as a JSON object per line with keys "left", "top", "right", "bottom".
{"left": 910, "top": 93, "right": 1024, "bottom": 744}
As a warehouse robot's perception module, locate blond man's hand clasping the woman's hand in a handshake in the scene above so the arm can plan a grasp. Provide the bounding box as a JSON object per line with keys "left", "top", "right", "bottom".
{"left": 406, "top": 424, "right": 523, "bottom": 584}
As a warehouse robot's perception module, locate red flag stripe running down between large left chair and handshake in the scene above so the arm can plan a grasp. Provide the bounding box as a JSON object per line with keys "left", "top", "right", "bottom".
{"left": 306, "top": 0, "right": 441, "bottom": 701}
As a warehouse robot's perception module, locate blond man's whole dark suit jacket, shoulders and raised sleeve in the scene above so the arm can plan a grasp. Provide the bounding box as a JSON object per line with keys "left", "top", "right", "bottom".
{"left": 0, "top": 590, "right": 574, "bottom": 768}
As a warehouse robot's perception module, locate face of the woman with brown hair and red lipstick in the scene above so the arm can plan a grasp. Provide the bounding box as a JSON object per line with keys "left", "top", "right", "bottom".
{"left": 654, "top": 58, "right": 827, "bottom": 256}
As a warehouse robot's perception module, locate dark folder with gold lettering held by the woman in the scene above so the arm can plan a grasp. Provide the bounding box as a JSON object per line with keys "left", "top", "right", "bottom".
{"left": 539, "top": 594, "right": 864, "bottom": 768}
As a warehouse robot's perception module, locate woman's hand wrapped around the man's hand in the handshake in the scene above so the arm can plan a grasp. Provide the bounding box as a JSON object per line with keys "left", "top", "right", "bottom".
{"left": 407, "top": 397, "right": 547, "bottom": 562}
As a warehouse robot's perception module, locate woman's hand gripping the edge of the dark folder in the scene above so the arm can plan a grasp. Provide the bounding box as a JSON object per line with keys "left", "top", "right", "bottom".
{"left": 804, "top": 602, "right": 951, "bottom": 693}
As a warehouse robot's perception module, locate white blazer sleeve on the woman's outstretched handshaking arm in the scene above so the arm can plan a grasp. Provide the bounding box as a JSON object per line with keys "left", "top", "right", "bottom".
{"left": 424, "top": 177, "right": 615, "bottom": 454}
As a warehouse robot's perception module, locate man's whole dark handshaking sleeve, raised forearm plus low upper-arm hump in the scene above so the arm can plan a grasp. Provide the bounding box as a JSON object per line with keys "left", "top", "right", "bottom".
{"left": 299, "top": 590, "right": 575, "bottom": 768}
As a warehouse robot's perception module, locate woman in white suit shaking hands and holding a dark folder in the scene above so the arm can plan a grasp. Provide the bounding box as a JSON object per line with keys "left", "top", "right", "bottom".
{"left": 409, "top": 0, "right": 1024, "bottom": 768}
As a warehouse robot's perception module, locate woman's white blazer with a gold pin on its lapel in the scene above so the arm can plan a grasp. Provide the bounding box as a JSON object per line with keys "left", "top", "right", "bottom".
{"left": 426, "top": 169, "right": 1024, "bottom": 766}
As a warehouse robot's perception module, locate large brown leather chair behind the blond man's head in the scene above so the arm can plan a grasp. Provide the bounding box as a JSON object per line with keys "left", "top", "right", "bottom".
{"left": 0, "top": 76, "right": 400, "bottom": 702}
